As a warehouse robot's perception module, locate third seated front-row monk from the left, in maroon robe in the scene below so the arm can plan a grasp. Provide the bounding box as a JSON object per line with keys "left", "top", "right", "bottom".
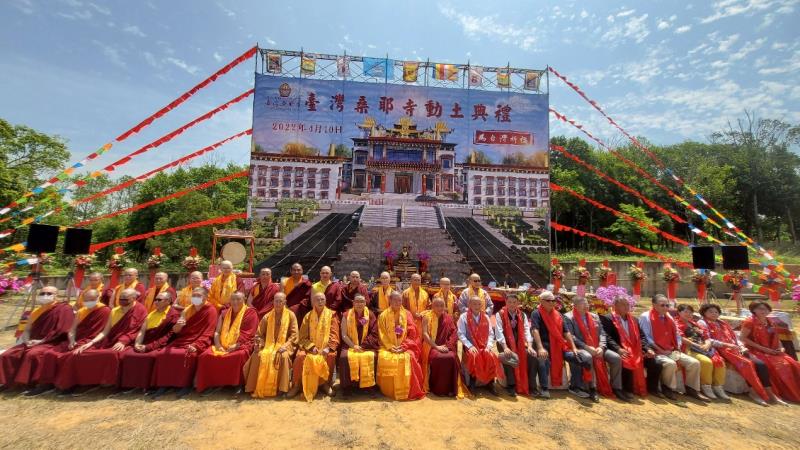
{"left": 54, "top": 291, "right": 150, "bottom": 392}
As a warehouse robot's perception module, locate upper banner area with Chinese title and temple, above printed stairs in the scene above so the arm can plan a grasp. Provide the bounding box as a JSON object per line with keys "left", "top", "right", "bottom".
{"left": 251, "top": 74, "right": 549, "bottom": 208}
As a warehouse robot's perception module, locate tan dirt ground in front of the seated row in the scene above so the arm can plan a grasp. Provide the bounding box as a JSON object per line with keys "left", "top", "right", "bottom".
{"left": 0, "top": 296, "right": 800, "bottom": 449}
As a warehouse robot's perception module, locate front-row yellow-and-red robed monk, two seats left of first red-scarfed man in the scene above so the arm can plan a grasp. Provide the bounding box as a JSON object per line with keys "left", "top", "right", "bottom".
{"left": 377, "top": 291, "right": 425, "bottom": 400}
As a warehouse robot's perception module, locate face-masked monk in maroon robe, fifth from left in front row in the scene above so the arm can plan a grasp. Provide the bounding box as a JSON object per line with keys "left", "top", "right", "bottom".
{"left": 151, "top": 289, "right": 219, "bottom": 399}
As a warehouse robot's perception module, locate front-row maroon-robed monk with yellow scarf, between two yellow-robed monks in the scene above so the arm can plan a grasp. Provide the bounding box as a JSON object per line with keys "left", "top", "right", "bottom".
{"left": 338, "top": 294, "right": 379, "bottom": 397}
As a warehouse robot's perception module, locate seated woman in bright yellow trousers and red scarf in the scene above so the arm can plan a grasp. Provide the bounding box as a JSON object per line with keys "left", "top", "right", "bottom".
{"left": 675, "top": 303, "right": 730, "bottom": 400}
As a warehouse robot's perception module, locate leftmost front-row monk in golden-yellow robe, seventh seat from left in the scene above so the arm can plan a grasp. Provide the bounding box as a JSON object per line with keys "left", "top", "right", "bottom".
{"left": 244, "top": 292, "right": 297, "bottom": 398}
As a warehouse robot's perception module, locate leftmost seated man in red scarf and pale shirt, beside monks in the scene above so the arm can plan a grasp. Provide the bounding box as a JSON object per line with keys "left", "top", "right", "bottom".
{"left": 458, "top": 296, "right": 505, "bottom": 395}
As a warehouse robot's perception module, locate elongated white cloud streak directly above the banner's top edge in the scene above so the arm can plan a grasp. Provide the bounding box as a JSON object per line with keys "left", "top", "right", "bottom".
{"left": 439, "top": 5, "right": 537, "bottom": 50}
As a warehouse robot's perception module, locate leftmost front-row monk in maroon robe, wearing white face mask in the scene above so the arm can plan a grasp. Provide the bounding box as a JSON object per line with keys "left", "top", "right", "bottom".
{"left": 0, "top": 286, "right": 75, "bottom": 386}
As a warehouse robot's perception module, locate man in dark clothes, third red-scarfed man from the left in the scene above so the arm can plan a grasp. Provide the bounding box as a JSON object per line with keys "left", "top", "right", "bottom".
{"left": 531, "top": 291, "right": 592, "bottom": 398}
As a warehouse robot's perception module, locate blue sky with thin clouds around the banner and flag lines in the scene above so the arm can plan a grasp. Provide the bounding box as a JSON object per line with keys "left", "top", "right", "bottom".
{"left": 0, "top": 0, "right": 800, "bottom": 181}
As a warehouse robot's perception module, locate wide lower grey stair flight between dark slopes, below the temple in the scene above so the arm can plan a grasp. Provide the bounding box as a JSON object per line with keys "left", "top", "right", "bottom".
{"left": 333, "top": 227, "right": 470, "bottom": 284}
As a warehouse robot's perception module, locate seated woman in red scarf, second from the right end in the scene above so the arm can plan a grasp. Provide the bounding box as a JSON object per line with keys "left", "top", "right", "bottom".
{"left": 698, "top": 303, "right": 784, "bottom": 406}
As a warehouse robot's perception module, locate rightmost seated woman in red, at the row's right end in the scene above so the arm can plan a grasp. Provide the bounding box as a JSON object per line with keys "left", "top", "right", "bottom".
{"left": 740, "top": 300, "right": 800, "bottom": 402}
